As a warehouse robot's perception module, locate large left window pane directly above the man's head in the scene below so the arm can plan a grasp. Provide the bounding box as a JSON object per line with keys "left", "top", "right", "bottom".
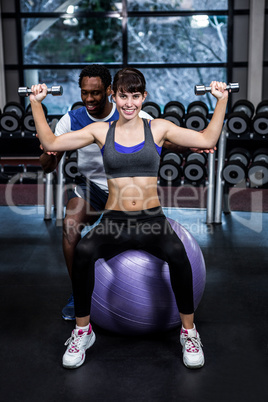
{"left": 22, "top": 18, "right": 122, "bottom": 64}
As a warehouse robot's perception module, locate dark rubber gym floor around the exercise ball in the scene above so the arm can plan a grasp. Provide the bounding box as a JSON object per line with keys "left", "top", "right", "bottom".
{"left": 0, "top": 206, "right": 268, "bottom": 402}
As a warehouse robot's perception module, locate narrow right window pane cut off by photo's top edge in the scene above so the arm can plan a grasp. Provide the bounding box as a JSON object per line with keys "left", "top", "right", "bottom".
{"left": 127, "top": 0, "right": 228, "bottom": 11}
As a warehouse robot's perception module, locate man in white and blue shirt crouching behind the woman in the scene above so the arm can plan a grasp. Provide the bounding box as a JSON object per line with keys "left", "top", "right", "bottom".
{"left": 40, "top": 65, "right": 152, "bottom": 320}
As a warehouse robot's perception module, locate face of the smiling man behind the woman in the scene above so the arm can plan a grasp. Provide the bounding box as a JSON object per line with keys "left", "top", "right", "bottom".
{"left": 81, "top": 77, "right": 110, "bottom": 119}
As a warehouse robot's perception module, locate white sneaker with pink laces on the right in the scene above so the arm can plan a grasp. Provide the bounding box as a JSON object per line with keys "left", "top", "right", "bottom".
{"left": 180, "top": 327, "right": 205, "bottom": 369}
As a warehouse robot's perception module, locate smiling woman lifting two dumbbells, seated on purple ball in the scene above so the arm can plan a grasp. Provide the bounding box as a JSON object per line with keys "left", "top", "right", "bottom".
{"left": 30, "top": 68, "right": 228, "bottom": 368}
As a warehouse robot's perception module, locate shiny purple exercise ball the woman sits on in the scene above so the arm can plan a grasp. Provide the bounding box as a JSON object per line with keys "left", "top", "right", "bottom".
{"left": 91, "top": 218, "right": 206, "bottom": 335}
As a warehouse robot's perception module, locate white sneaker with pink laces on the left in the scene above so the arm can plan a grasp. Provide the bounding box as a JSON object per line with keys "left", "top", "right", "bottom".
{"left": 62, "top": 325, "right": 96, "bottom": 369}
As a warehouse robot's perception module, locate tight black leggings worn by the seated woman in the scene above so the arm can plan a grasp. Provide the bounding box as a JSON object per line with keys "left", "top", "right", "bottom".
{"left": 72, "top": 207, "right": 194, "bottom": 317}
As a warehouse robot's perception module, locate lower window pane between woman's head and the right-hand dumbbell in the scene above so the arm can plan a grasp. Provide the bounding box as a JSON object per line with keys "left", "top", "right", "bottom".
{"left": 140, "top": 68, "right": 226, "bottom": 112}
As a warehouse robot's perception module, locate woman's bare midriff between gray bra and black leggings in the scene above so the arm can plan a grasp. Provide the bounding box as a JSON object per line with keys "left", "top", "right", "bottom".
{"left": 105, "top": 177, "right": 160, "bottom": 211}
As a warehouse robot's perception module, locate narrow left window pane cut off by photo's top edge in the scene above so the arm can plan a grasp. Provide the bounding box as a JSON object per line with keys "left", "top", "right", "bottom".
{"left": 20, "top": 0, "right": 122, "bottom": 13}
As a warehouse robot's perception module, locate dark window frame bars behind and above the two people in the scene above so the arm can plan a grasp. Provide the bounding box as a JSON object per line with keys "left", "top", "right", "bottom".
{"left": 2, "top": 0, "right": 236, "bottom": 115}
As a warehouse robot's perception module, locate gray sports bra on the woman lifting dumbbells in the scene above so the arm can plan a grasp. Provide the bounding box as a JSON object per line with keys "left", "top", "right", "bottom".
{"left": 103, "top": 119, "right": 160, "bottom": 179}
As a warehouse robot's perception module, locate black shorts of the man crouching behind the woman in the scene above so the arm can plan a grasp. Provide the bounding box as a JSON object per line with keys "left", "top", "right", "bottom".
{"left": 69, "top": 176, "right": 108, "bottom": 211}
